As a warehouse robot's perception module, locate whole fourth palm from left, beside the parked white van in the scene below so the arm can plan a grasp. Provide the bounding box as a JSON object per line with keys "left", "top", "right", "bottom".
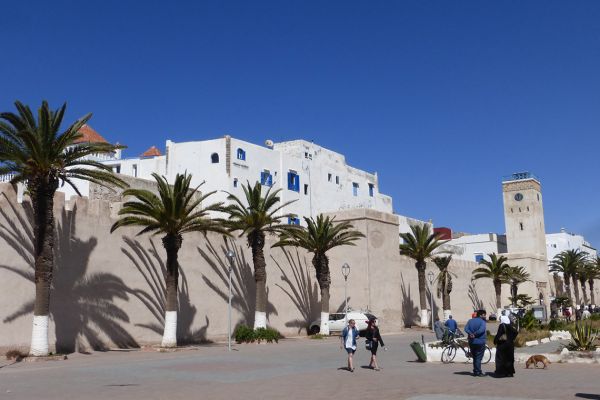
{"left": 273, "top": 214, "right": 365, "bottom": 335}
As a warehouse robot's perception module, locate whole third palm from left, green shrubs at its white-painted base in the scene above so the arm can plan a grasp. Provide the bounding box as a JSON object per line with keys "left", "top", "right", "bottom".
{"left": 225, "top": 182, "right": 297, "bottom": 329}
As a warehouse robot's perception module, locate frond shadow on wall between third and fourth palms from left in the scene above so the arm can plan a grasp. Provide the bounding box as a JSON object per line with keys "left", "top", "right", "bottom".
{"left": 271, "top": 248, "right": 318, "bottom": 333}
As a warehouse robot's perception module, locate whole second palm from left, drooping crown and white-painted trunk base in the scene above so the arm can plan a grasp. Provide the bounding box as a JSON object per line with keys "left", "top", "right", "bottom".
{"left": 110, "top": 173, "right": 228, "bottom": 347}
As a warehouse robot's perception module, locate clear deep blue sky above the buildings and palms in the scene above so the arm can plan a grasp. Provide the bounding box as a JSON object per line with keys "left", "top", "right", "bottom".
{"left": 0, "top": 1, "right": 600, "bottom": 247}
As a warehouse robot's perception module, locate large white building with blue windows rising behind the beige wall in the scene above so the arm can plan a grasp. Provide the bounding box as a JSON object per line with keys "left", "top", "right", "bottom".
{"left": 61, "top": 129, "right": 393, "bottom": 223}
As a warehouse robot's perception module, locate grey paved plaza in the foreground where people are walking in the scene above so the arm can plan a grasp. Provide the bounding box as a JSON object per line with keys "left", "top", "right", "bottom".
{"left": 0, "top": 331, "right": 600, "bottom": 400}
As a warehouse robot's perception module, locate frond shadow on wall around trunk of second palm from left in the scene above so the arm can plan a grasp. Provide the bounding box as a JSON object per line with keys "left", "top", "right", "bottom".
{"left": 121, "top": 236, "right": 210, "bottom": 345}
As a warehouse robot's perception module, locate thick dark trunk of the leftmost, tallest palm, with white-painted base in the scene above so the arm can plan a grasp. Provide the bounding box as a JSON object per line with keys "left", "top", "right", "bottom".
{"left": 30, "top": 180, "right": 58, "bottom": 356}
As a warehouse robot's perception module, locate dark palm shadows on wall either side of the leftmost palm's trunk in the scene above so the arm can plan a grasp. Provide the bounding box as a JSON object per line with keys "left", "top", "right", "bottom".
{"left": 0, "top": 197, "right": 138, "bottom": 353}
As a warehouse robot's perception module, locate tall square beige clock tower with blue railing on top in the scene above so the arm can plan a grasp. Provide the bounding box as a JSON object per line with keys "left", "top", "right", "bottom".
{"left": 502, "top": 172, "right": 550, "bottom": 307}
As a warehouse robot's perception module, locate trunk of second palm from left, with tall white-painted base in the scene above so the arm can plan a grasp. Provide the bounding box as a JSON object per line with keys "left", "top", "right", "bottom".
{"left": 161, "top": 234, "right": 183, "bottom": 347}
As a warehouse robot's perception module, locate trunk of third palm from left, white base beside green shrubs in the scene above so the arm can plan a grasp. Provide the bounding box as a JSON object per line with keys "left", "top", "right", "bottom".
{"left": 248, "top": 231, "right": 267, "bottom": 329}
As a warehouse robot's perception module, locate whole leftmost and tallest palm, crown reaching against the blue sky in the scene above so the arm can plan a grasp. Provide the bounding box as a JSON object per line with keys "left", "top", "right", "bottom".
{"left": 0, "top": 101, "right": 126, "bottom": 356}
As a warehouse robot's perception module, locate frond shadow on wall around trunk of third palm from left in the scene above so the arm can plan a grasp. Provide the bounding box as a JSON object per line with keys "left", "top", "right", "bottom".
{"left": 198, "top": 237, "right": 278, "bottom": 326}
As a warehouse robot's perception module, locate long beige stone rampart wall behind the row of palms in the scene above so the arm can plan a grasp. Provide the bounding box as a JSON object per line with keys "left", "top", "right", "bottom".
{"left": 0, "top": 184, "right": 548, "bottom": 351}
